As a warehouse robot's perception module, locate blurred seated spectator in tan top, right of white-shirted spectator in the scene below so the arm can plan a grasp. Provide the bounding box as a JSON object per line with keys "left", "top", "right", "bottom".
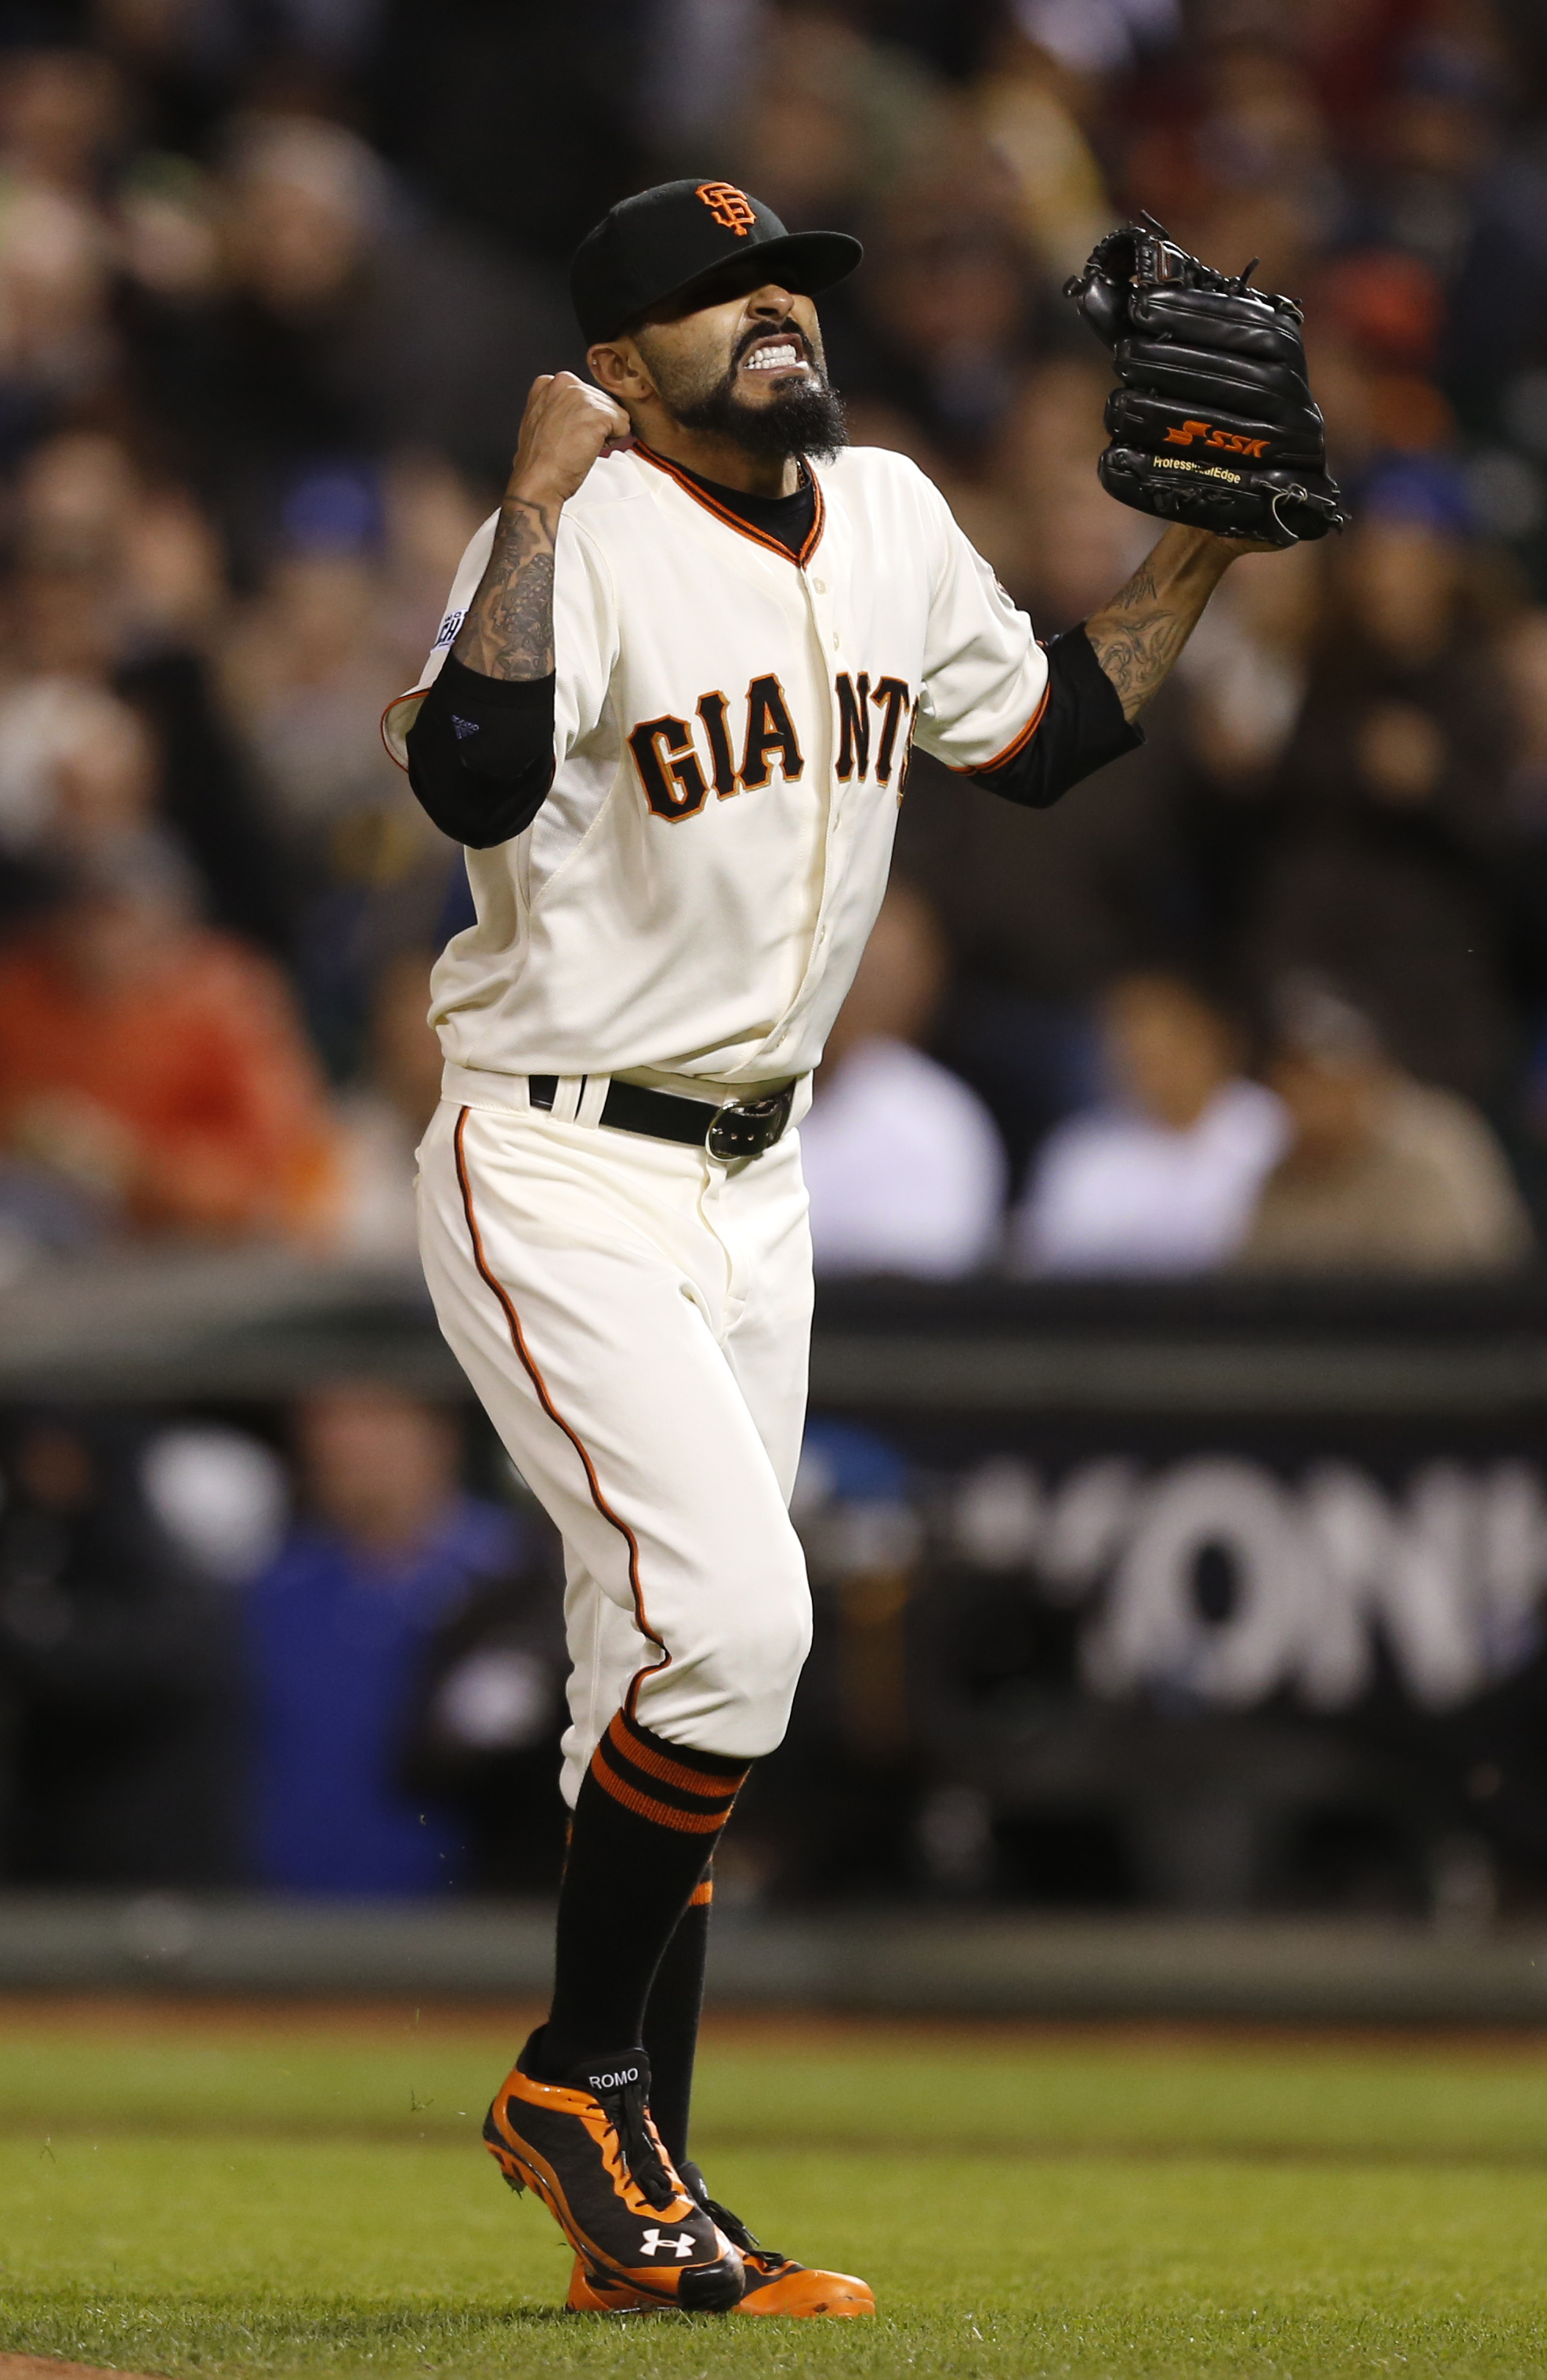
{"left": 1240, "top": 978, "right": 1531, "bottom": 1273}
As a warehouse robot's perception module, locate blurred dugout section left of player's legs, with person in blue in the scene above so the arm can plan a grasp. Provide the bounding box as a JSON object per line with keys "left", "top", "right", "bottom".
{"left": 0, "top": 1380, "right": 564, "bottom": 1895}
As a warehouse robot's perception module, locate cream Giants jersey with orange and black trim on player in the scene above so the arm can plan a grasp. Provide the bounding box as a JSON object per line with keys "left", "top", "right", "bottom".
{"left": 383, "top": 448, "right": 1047, "bottom": 1087}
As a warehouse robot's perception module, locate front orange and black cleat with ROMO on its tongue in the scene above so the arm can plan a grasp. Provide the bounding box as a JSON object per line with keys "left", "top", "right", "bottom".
{"left": 483, "top": 2033, "right": 745, "bottom": 2313}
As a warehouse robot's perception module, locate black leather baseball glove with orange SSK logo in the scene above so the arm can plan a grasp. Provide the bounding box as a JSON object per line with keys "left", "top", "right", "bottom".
{"left": 1064, "top": 223, "right": 1347, "bottom": 545}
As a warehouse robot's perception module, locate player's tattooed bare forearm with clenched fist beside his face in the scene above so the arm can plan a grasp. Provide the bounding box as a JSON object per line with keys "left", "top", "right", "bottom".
{"left": 452, "top": 372, "right": 629, "bottom": 678}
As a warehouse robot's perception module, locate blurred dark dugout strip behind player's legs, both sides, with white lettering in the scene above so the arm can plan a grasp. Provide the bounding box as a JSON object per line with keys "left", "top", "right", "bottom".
{"left": 12, "top": 1378, "right": 1547, "bottom": 1923}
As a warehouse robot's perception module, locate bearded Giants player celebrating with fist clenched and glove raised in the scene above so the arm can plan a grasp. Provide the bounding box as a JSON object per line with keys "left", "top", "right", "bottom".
{"left": 383, "top": 181, "right": 1342, "bottom": 2316}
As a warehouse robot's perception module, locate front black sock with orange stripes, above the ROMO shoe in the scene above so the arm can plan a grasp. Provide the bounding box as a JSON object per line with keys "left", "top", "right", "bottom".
{"left": 540, "top": 1711, "right": 748, "bottom": 2075}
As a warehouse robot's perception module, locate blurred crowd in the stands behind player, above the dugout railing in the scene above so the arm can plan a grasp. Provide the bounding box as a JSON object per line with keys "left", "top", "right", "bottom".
{"left": 0, "top": 0, "right": 1547, "bottom": 1275}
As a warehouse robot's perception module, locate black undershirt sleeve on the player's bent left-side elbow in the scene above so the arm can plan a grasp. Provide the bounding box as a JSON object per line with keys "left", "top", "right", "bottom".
{"left": 407, "top": 652, "right": 555, "bottom": 852}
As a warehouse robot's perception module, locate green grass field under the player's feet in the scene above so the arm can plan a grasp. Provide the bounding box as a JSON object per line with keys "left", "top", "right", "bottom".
{"left": 0, "top": 2004, "right": 1547, "bottom": 2380}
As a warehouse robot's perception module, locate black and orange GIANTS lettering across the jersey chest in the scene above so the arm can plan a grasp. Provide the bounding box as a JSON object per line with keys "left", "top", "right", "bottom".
{"left": 629, "top": 671, "right": 909, "bottom": 821}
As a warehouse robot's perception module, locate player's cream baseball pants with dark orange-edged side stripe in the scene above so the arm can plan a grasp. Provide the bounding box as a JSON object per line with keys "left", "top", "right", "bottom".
{"left": 418, "top": 1068, "right": 812, "bottom": 1806}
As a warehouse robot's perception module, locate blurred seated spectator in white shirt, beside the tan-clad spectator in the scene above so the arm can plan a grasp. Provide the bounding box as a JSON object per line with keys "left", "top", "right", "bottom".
{"left": 1014, "top": 974, "right": 1288, "bottom": 1273}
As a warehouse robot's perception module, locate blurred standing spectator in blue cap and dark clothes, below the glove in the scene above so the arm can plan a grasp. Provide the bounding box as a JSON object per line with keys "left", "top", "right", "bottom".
{"left": 1233, "top": 457, "right": 1519, "bottom": 1100}
